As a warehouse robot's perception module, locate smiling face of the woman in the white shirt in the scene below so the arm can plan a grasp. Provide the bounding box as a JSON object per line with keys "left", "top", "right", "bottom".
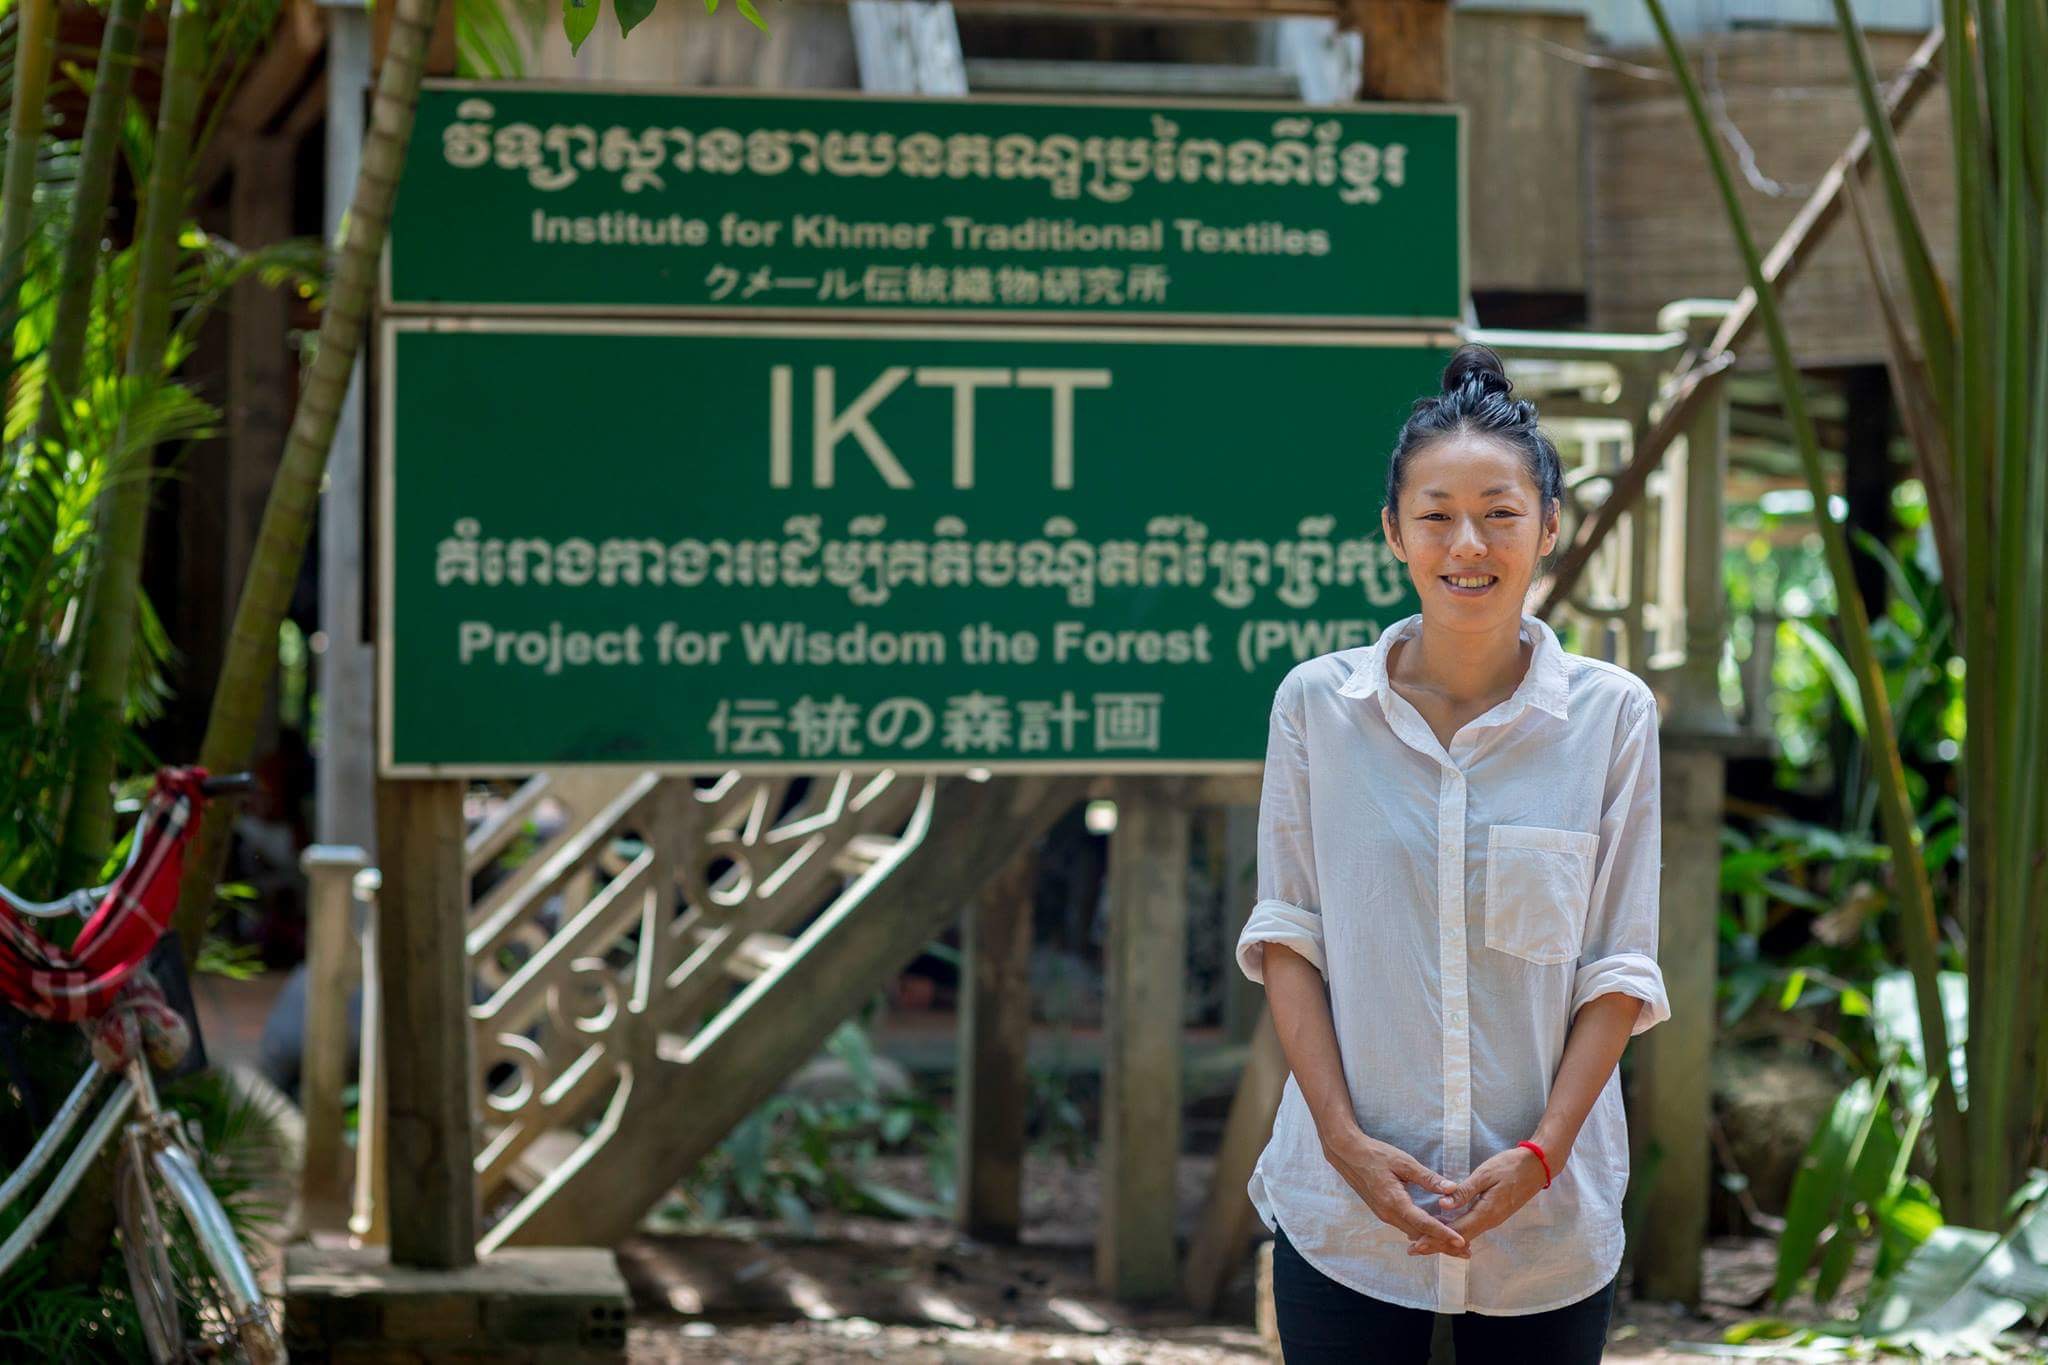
{"left": 1380, "top": 436, "right": 1556, "bottom": 630}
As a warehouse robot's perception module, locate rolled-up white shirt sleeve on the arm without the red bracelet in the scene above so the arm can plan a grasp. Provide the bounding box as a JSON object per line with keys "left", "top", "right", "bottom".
{"left": 1237, "top": 671, "right": 1329, "bottom": 984}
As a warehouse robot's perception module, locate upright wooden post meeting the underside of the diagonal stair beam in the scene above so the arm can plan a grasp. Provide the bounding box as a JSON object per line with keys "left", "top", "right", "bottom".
{"left": 954, "top": 845, "right": 1038, "bottom": 1242}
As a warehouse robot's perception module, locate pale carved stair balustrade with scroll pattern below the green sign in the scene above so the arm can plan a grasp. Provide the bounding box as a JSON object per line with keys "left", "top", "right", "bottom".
{"left": 307, "top": 769, "right": 934, "bottom": 1240}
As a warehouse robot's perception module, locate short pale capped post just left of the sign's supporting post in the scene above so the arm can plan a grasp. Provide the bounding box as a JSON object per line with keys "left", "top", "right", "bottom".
{"left": 299, "top": 843, "right": 369, "bottom": 1232}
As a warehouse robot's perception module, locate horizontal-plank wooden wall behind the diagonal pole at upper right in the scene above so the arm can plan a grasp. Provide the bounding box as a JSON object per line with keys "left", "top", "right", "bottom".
{"left": 1587, "top": 29, "right": 1956, "bottom": 368}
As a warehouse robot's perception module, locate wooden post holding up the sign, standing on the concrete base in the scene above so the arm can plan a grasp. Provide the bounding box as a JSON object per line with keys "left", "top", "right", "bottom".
{"left": 377, "top": 782, "right": 477, "bottom": 1271}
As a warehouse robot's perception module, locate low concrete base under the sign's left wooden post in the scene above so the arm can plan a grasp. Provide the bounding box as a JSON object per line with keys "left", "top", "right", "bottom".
{"left": 285, "top": 1242, "right": 631, "bottom": 1365}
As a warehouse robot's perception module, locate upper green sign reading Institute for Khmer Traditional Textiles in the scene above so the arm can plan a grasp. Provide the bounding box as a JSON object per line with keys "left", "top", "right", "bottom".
{"left": 387, "top": 82, "right": 1466, "bottom": 325}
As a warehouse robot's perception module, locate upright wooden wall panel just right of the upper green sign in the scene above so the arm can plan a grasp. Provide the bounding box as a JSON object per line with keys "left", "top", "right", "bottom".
{"left": 1450, "top": 6, "right": 1589, "bottom": 293}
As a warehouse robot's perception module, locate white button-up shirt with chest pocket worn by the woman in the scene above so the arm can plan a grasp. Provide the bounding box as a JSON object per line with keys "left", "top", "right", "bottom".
{"left": 1237, "top": 614, "right": 1671, "bottom": 1314}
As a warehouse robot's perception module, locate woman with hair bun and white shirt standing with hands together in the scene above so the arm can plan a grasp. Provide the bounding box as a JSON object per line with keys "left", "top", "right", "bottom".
{"left": 1237, "top": 346, "right": 1671, "bottom": 1365}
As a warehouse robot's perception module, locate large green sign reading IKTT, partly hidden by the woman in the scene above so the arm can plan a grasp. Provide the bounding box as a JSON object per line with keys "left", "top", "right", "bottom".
{"left": 379, "top": 319, "right": 1450, "bottom": 776}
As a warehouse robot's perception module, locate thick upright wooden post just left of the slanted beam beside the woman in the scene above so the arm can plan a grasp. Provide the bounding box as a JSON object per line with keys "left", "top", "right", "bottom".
{"left": 1096, "top": 780, "right": 1188, "bottom": 1300}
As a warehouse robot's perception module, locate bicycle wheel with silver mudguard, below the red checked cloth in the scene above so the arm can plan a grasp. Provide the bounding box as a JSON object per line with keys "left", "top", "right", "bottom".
{"left": 117, "top": 1136, "right": 285, "bottom": 1365}
